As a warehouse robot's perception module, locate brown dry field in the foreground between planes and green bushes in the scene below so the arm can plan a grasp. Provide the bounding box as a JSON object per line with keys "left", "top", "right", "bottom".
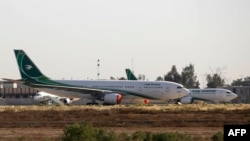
{"left": 0, "top": 104, "right": 250, "bottom": 141}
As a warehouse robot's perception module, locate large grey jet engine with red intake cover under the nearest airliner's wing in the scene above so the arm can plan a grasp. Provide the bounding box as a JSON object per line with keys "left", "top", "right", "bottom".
{"left": 104, "top": 93, "right": 122, "bottom": 104}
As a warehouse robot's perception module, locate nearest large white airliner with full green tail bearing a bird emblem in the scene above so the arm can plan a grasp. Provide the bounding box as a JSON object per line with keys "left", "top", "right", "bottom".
{"left": 3, "top": 50, "right": 189, "bottom": 105}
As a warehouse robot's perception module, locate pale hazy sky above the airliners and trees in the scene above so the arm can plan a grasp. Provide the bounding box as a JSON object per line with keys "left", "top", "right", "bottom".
{"left": 0, "top": 0, "right": 250, "bottom": 87}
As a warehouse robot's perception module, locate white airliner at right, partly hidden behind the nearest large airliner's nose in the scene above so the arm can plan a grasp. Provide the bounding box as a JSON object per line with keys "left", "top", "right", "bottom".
{"left": 125, "top": 69, "right": 238, "bottom": 104}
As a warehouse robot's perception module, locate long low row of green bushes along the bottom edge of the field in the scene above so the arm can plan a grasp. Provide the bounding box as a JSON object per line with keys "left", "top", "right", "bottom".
{"left": 62, "top": 123, "right": 193, "bottom": 141}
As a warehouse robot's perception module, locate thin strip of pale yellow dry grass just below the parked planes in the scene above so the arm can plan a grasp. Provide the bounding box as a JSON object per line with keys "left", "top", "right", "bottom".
{"left": 0, "top": 104, "right": 250, "bottom": 112}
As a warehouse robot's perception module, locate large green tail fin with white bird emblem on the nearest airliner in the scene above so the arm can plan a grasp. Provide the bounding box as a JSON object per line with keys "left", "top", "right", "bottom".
{"left": 14, "top": 50, "right": 50, "bottom": 84}
